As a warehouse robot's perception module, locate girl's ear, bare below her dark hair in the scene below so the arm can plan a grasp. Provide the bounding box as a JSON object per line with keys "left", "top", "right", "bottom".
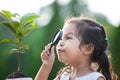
{"left": 82, "top": 43, "right": 94, "bottom": 54}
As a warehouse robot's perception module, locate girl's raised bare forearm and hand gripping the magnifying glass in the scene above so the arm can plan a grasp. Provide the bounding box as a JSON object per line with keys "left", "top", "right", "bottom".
{"left": 35, "top": 44, "right": 55, "bottom": 80}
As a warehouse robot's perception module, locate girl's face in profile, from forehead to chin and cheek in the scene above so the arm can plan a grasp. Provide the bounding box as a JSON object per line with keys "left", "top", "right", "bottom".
{"left": 56, "top": 23, "right": 86, "bottom": 65}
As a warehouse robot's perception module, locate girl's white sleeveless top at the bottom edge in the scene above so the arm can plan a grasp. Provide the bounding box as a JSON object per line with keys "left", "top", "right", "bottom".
{"left": 56, "top": 72, "right": 106, "bottom": 80}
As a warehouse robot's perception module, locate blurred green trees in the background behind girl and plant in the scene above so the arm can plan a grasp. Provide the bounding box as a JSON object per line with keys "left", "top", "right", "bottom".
{"left": 0, "top": 0, "right": 120, "bottom": 80}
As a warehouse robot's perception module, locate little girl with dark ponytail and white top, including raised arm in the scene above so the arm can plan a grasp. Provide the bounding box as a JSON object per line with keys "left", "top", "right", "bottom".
{"left": 35, "top": 17, "right": 111, "bottom": 80}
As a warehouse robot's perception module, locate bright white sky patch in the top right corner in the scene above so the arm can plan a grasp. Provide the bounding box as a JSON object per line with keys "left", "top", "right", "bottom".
{"left": 86, "top": 0, "right": 120, "bottom": 26}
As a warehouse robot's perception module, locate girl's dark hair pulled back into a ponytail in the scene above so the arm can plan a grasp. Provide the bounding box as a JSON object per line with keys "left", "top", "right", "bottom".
{"left": 67, "top": 18, "right": 112, "bottom": 80}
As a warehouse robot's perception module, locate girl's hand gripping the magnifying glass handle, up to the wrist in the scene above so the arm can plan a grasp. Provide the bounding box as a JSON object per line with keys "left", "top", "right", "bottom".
{"left": 41, "top": 44, "right": 55, "bottom": 67}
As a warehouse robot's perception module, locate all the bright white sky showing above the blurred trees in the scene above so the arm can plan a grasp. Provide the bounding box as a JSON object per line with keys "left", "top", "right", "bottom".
{"left": 0, "top": 0, "right": 120, "bottom": 26}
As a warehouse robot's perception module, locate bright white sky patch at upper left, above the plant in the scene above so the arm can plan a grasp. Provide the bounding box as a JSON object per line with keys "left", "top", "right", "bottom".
{"left": 0, "top": 0, "right": 54, "bottom": 15}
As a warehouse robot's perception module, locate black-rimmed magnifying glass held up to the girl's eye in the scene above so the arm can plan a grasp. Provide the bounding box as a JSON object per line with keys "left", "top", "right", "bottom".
{"left": 49, "top": 29, "right": 63, "bottom": 50}
